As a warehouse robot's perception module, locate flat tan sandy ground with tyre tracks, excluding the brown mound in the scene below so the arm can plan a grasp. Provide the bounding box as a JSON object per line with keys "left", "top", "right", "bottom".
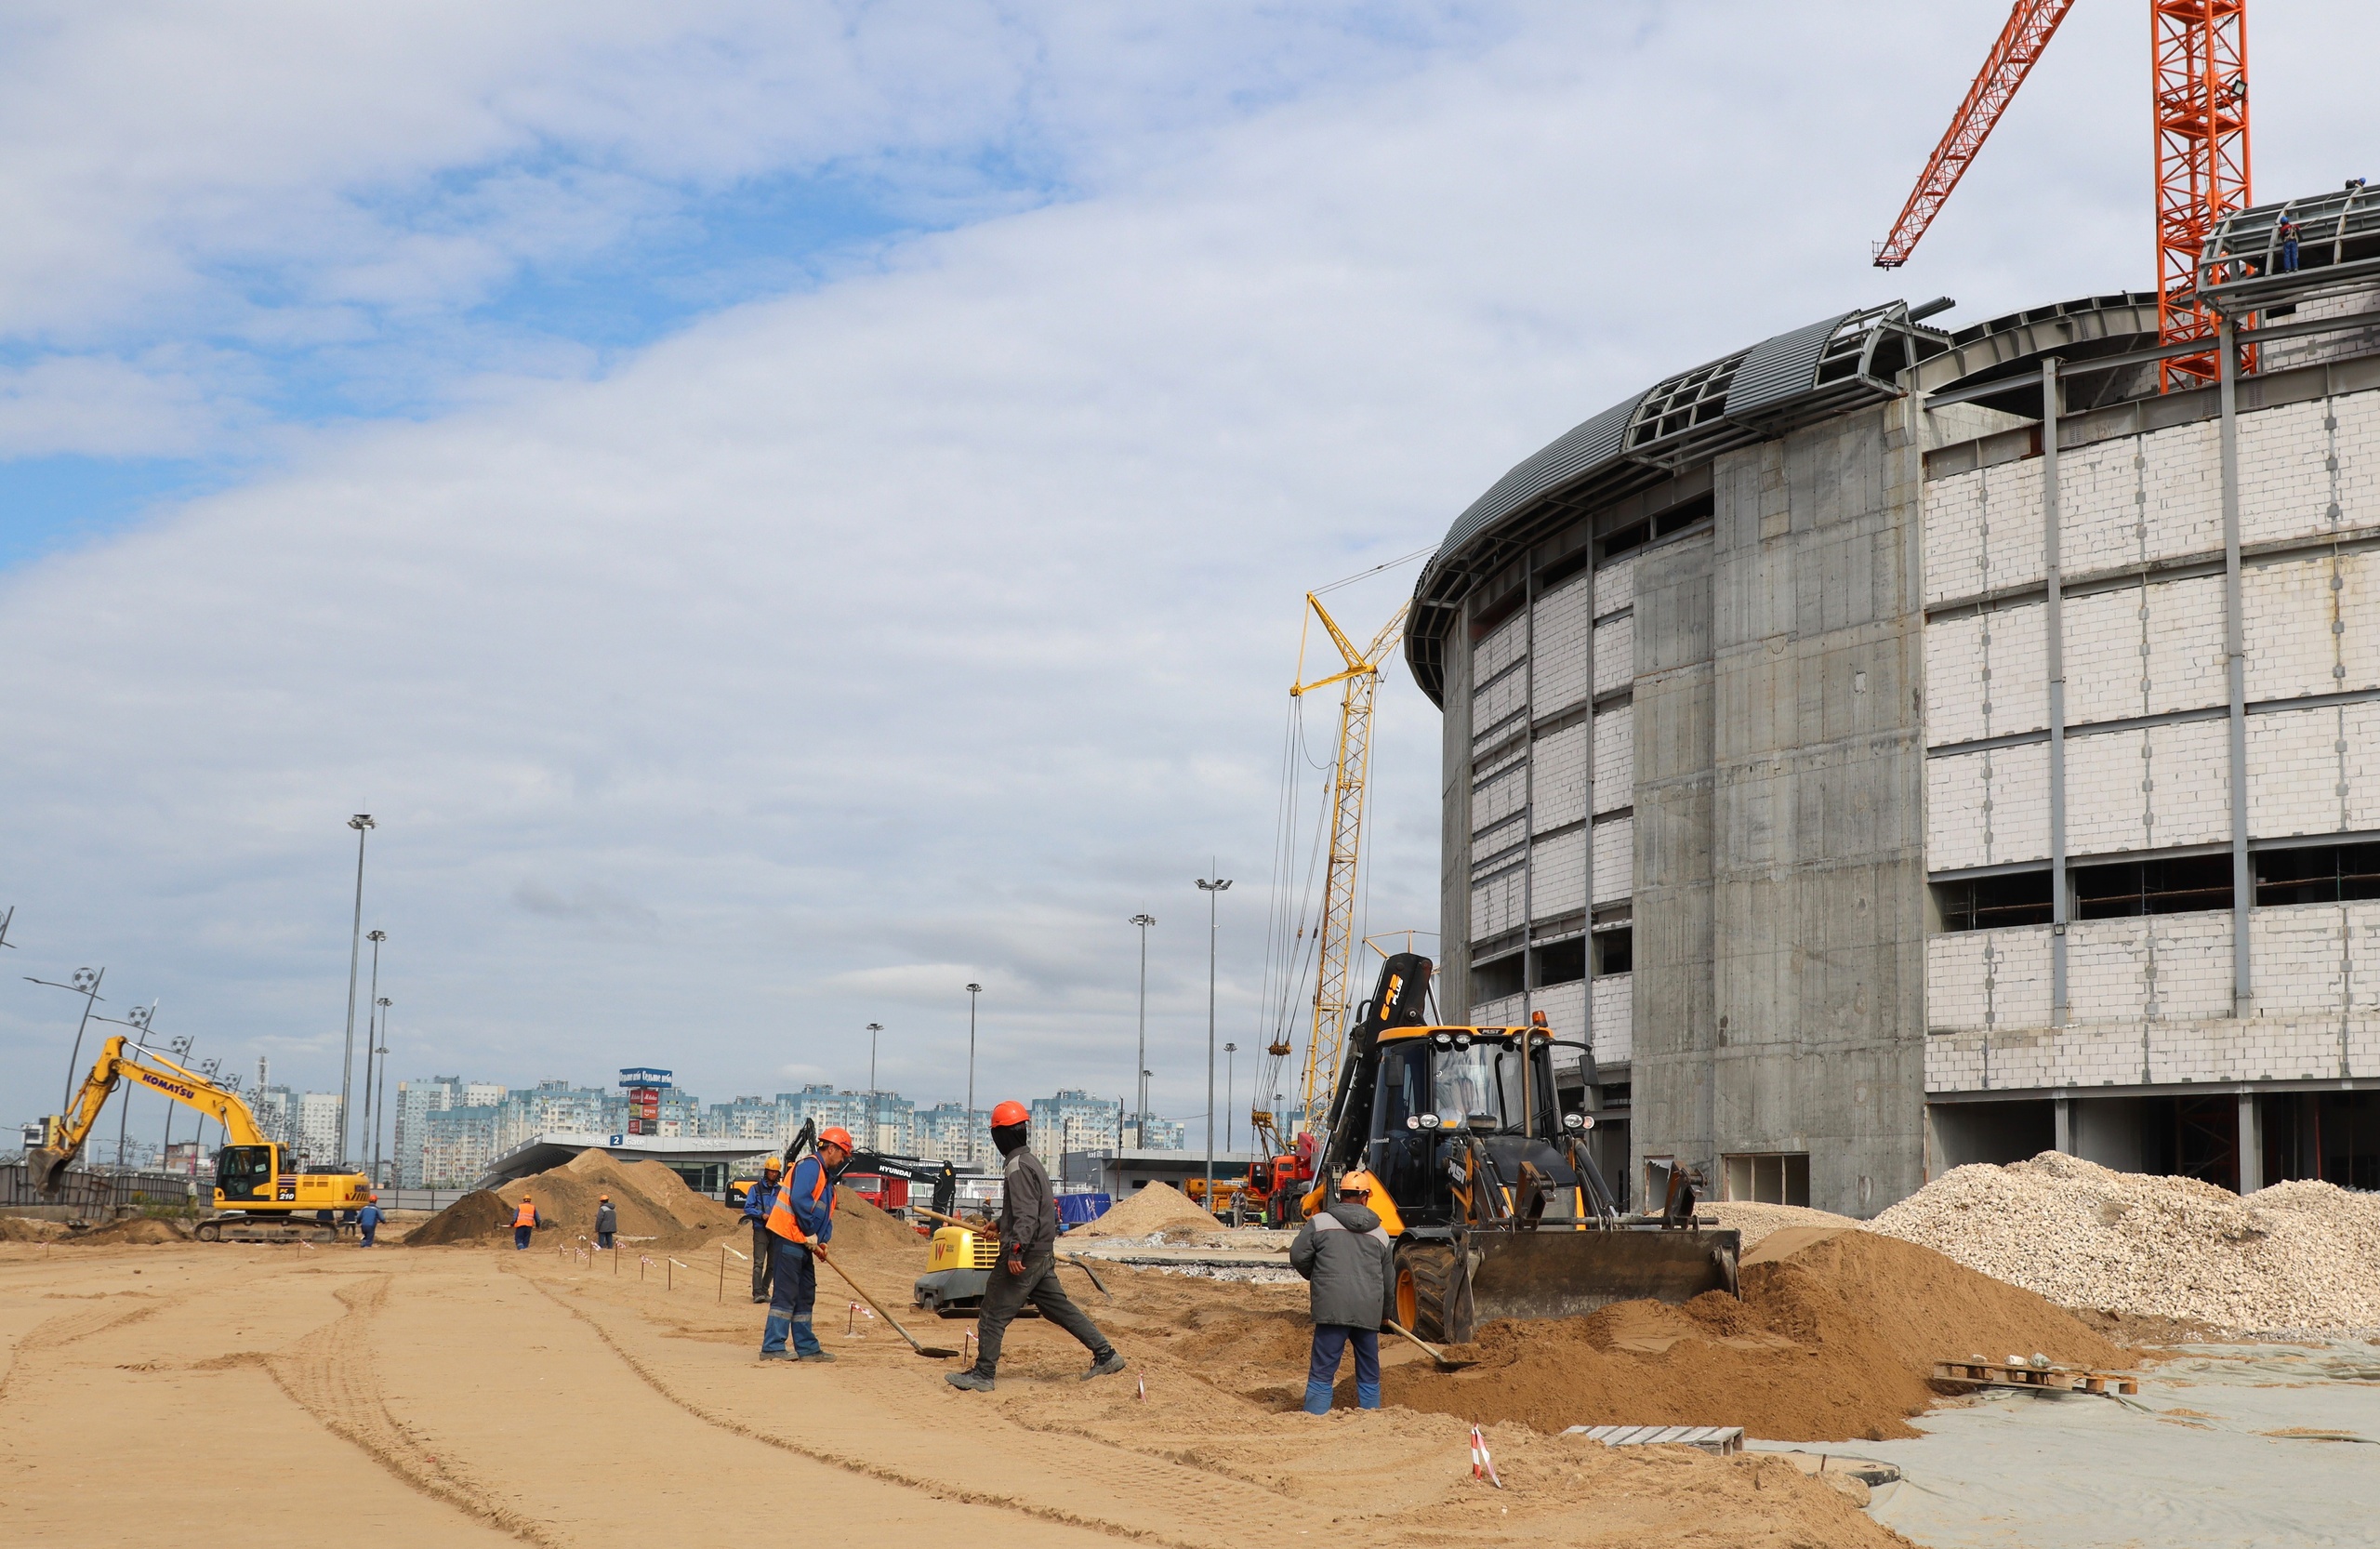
{"left": 0, "top": 1242, "right": 1907, "bottom": 1549}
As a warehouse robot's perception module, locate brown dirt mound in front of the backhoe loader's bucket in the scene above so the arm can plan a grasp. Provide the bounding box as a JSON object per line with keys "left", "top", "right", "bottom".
{"left": 1382, "top": 1228, "right": 2130, "bottom": 1442}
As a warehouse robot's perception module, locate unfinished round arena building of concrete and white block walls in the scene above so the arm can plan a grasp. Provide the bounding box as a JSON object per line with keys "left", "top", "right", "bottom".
{"left": 1404, "top": 188, "right": 2380, "bottom": 1216}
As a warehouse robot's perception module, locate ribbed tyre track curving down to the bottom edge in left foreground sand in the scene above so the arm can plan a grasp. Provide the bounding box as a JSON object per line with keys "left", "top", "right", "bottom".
{"left": 260, "top": 1273, "right": 564, "bottom": 1549}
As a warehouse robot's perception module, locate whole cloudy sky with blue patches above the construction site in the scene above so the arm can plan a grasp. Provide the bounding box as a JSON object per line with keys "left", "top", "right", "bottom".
{"left": 0, "top": 3, "right": 2380, "bottom": 1156}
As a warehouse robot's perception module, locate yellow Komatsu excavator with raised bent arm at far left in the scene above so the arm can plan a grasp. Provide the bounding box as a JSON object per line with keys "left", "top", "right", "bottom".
{"left": 26, "top": 1038, "right": 371, "bottom": 1242}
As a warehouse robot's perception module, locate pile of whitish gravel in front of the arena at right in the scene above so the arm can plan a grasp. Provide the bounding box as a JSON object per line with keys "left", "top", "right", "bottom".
{"left": 1869, "top": 1152, "right": 2380, "bottom": 1332}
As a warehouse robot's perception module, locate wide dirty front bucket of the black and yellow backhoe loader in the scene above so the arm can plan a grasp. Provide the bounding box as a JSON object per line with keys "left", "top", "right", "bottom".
{"left": 1445, "top": 1228, "right": 1742, "bottom": 1344}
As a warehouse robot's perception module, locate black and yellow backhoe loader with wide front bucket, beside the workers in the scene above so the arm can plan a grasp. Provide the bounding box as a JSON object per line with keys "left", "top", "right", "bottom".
{"left": 1302, "top": 952, "right": 1742, "bottom": 1344}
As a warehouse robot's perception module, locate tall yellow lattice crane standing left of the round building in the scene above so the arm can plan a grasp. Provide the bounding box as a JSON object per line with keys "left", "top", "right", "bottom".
{"left": 1250, "top": 592, "right": 1407, "bottom": 1227}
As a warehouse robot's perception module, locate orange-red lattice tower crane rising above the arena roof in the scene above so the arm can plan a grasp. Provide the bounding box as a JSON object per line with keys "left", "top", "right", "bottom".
{"left": 1875, "top": 0, "right": 2252, "bottom": 391}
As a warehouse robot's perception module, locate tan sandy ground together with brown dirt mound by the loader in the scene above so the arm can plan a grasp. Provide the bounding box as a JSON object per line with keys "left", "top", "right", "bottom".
{"left": 0, "top": 1180, "right": 2179, "bottom": 1549}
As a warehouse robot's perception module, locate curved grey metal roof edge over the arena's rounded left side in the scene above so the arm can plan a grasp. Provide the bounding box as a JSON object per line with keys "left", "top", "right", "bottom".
{"left": 1404, "top": 302, "right": 1950, "bottom": 699}
